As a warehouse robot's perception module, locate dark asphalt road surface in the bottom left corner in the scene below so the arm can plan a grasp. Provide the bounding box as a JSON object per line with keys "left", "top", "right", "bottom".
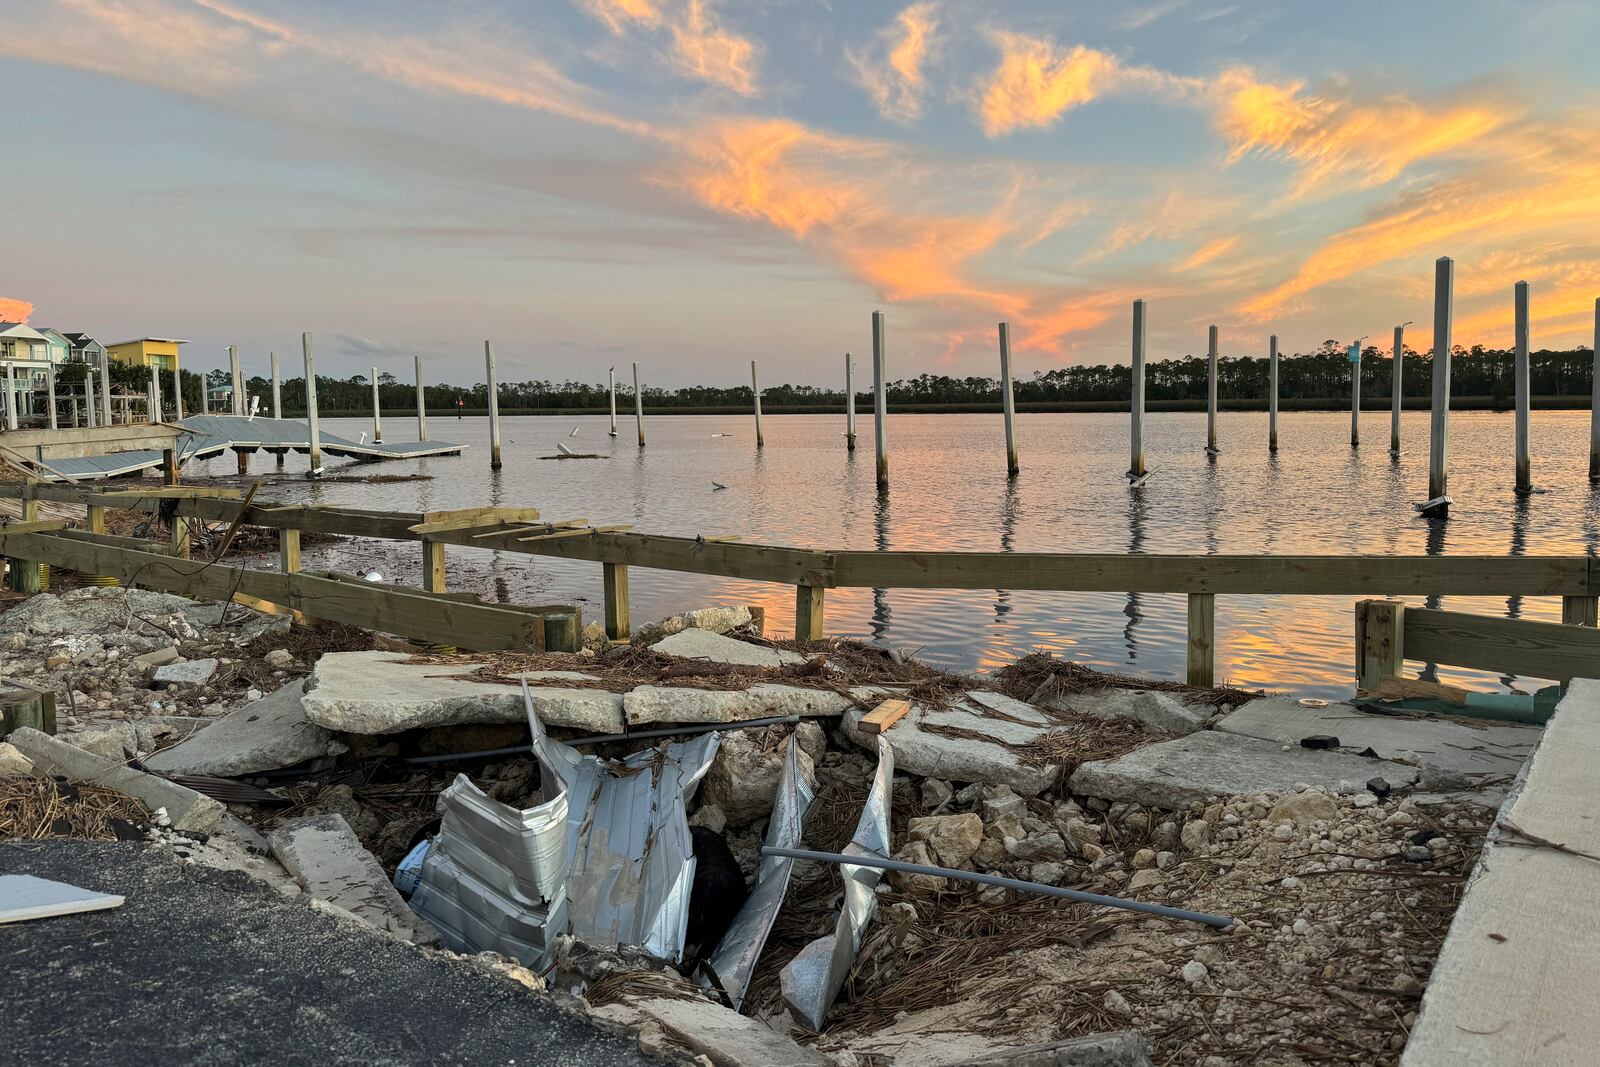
{"left": 0, "top": 841, "right": 661, "bottom": 1067}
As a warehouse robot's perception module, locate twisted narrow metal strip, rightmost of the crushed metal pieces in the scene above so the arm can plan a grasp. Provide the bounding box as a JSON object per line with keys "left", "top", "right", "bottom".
{"left": 777, "top": 734, "right": 894, "bottom": 1030}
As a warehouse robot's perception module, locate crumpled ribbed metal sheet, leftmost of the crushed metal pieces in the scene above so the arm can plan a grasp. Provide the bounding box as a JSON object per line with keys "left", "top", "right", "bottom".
{"left": 411, "top": 768, "right": 570, "bottom": 969}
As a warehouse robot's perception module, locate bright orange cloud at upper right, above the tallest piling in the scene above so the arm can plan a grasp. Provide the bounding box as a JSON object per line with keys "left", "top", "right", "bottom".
{"left": 1210, "top": 67, "right": 1514, "bottom": 195}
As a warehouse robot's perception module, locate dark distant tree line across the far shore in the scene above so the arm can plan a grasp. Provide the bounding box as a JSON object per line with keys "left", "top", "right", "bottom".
{"left": 203, "top": 339, "right": 1594, "bottom": 414}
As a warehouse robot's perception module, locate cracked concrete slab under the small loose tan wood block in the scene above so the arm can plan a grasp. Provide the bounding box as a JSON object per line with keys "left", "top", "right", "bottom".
{"left": 840, "top": 691, "right": 1061, "bottom": 797}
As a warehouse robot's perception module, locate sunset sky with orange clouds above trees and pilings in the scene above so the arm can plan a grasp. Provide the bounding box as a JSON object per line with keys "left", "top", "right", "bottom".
{"left": 0, "top": 0, "right": 1600, "bottom": 386}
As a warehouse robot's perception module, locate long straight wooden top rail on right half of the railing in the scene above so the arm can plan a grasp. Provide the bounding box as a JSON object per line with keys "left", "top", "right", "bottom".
{"left": 826, "top": 552, "right": 1595, "bottom": 597}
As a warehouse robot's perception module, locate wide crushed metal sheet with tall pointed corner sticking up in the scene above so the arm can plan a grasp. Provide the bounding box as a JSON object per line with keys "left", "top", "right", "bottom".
{"left": 522, "top": 680, "right": 722, "bottom": 963}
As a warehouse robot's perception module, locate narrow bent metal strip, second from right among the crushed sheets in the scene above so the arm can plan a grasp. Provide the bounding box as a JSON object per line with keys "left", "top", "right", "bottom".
{"left": 706, "top": 734, "right": 813, "bottom": 1011}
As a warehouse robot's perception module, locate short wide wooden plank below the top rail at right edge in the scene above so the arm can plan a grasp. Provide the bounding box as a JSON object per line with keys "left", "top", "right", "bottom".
{"left": 1405, "top": 608, "right": 1600, "bottom": 681}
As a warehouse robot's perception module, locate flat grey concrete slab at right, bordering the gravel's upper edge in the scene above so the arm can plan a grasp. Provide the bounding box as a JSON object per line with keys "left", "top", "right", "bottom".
{"left": 1067, "top": 729, "right": 1418, "bottom": 811}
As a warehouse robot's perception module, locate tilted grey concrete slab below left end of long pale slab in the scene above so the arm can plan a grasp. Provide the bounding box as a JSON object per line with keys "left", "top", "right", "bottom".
{"left": 144, "top": 678, "right": 346, "bottom": 776}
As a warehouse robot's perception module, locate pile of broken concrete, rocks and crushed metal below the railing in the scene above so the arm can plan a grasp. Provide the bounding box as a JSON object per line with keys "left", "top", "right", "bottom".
{"left": 0, "top": 590, "right": 1538, "bottom": 1067}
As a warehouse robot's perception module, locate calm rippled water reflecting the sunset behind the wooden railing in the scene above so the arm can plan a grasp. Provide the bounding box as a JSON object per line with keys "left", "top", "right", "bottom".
{"left": 194, "top": 411, "right": 1600, "bottom": 696}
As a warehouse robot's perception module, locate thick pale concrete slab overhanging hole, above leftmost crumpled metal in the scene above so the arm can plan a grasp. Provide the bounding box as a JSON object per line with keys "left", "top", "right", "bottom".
{"left": 304, "top": 651, "right": 624, "bottom": 734}
